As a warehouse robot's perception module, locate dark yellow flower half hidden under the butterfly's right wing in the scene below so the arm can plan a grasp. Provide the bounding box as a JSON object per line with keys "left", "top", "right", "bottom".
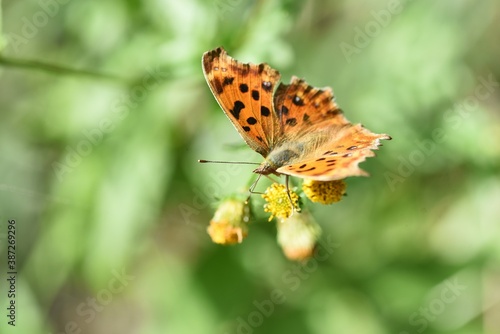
{"left": 302, "top": 179, "right": 346, "bottom": 204}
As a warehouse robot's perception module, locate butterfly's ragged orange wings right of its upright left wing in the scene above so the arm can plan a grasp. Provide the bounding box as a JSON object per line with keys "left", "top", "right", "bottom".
{"left": 271, "top": 77, "right": 390, "bottom": 181}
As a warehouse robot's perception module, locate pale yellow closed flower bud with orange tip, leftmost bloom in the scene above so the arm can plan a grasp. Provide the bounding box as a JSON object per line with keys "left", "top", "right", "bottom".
{"left": 207, "top": 198, "right": 250, "bottom": 245}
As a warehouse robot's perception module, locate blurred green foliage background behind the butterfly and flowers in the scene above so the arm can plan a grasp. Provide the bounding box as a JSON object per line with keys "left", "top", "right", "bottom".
{"left": 0, "top": 0, "right": 500, "bottom": 334}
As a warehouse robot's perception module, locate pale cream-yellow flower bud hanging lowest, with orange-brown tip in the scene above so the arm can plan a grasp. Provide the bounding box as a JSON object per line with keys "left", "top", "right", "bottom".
{"left": 278, "top": 212, "right": 321, "bottom": 261}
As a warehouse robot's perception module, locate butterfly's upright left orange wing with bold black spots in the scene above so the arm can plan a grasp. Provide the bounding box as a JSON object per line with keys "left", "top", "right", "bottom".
{"left": 202, "top": 47, "right": 280, "bottom": 157}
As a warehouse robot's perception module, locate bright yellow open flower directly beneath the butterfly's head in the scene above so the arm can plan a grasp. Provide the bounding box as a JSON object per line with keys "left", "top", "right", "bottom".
{"left": 262, "top": 183, "right": 300, "bottom": 221}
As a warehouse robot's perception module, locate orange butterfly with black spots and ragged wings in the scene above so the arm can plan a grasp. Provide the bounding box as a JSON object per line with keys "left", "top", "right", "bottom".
{"left": 202, "top": 47, "right": 391, "bottom": 181}
